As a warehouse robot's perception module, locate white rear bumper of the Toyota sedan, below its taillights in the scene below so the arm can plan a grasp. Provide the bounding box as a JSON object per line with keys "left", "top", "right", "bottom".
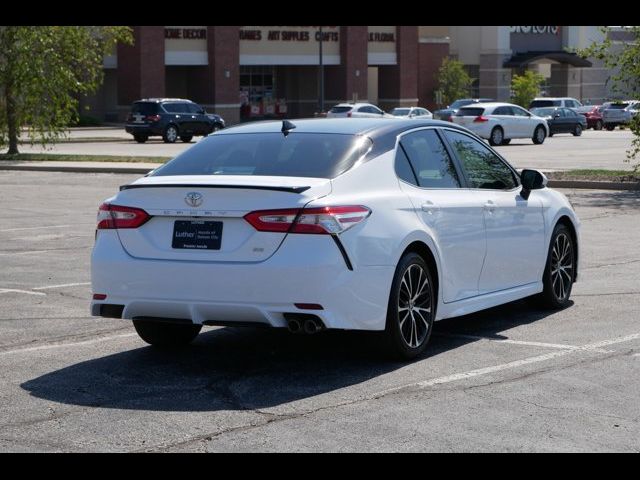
{"left": 91, "top": 230, "right": 395, "bottom": 330}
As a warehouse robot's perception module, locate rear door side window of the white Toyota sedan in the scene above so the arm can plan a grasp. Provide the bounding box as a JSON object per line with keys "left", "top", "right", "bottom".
{"left": 400, "top": 130, "right": 460, "bottom": 188}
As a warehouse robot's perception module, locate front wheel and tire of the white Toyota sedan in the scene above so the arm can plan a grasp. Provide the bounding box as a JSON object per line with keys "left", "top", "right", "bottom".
{"left": 540, "top": 223, "right": 576, "bottom": 310}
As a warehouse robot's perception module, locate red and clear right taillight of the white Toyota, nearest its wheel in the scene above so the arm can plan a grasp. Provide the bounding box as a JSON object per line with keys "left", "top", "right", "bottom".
{"left": 244, "top": 205, "right": 371, "bottom": 235}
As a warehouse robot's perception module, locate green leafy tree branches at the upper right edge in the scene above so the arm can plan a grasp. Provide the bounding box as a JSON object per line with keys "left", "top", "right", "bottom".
{"left": 573, "top": 26, "right": 640, "bottom": 173}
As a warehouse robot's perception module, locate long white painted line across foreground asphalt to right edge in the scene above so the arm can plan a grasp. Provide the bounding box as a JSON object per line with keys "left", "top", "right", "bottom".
{"left": 368, "top": 333, "right": 640, "bottom": 398}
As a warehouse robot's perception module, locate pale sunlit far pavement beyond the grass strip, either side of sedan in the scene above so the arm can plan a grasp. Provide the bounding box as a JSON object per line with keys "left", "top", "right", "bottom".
{"left": 6, "top": 129, "right": 633, "bottom": 171}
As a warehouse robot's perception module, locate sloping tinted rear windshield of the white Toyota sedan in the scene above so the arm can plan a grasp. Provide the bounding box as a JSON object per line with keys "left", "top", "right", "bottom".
{"left": 151, "top": 132, "right": 372, "bottom": 178}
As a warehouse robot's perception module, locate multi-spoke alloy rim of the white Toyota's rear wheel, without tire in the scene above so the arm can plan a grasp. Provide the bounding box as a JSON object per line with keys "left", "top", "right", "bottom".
{"left": 398, "top": 264, "right": 432, "bottom": 348}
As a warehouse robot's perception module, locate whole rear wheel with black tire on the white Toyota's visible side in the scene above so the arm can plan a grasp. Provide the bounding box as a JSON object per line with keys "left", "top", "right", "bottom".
{"left": 384, "top": 252, "right": 436, "bottom": 360}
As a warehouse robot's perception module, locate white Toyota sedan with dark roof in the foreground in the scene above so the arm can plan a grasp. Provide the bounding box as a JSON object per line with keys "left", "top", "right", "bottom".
{"left": 91, "top": 119, "right": 580, "bottom": 358}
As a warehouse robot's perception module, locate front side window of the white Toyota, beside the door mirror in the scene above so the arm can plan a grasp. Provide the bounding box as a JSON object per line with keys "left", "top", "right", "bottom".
{"left": 445, "top": 130, "right": 518, "bottom": 190}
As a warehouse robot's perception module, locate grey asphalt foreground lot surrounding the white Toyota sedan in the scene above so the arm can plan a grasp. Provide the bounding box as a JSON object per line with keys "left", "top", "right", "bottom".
{"left": 0, "top": 171, "right": 640, "bottom": 452}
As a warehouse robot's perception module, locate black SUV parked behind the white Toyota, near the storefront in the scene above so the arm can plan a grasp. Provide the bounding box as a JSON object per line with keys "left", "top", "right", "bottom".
{"left": 125, "top": 98, "right": 224, "bottom": 143}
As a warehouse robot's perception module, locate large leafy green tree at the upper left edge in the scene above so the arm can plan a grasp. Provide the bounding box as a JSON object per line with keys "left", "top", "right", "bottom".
{"left": 0, "top": 26, "right": 133, "bottom": 154}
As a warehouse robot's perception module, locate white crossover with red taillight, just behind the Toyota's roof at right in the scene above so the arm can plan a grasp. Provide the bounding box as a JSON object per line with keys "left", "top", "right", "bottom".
{"left": 453, "top": 102, "right": 549, "bottom": 146}
